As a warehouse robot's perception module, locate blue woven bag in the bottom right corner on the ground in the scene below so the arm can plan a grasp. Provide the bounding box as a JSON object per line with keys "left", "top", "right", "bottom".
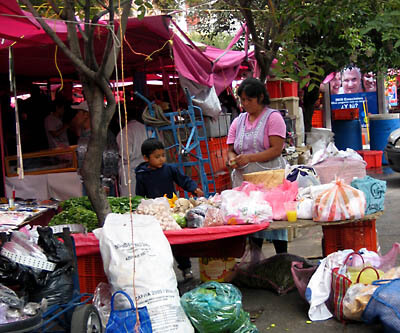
{"left": 362, "top": 279, "right": 400, "bottom": 332}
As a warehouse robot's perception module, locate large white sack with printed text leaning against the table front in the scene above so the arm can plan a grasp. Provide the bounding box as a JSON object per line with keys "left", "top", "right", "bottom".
{"left": 93, "top": 214, "right": 194, "bottom": 333}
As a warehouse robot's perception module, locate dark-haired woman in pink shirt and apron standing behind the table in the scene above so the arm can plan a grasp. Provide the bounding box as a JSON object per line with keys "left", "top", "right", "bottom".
{"left": 227, "top": 78, "right": 288, "bottom": 253}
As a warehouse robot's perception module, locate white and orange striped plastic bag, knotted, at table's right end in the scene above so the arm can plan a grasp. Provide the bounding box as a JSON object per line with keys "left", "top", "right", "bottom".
{"left": 313, "top": 179, "right": 366, "bottom": 222}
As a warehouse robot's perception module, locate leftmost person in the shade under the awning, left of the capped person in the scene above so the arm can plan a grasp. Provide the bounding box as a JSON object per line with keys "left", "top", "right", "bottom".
{"left": 44, "top": 98, "right": 69, "bottom": 148}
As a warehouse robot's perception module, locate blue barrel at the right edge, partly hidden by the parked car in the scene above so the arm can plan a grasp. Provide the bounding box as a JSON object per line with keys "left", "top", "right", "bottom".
{"left": 368, "top": 113, "right": 400, "bottom": 164}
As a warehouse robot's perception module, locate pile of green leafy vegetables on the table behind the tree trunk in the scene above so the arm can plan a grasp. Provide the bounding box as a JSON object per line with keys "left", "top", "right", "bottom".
{"left": 49, "top": 195, "right": 143, "bottom": 232}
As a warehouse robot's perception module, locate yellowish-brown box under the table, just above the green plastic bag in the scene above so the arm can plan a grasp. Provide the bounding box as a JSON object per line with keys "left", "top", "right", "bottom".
{"left": 199, "top": 257, "right": 236, "bottom": 282}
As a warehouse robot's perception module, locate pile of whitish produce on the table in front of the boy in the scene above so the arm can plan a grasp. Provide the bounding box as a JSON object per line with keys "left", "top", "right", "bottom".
{"left": 137, "top": 197, "right": 181, "bottom": 230}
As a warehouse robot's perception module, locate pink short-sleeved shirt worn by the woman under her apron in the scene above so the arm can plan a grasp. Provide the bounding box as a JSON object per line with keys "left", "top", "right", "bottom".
{"left": 226, "top": 110, "right": 286, "bottom": 149}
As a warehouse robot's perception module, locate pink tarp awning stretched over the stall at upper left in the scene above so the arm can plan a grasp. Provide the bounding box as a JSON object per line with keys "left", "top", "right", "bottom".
{"left": 0, "top": 0, "right": 255, "bottom": 93}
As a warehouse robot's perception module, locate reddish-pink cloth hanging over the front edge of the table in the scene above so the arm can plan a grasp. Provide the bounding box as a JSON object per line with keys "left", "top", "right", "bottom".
{"left": 72, "top": 222, "right": 269, "bottom": 253}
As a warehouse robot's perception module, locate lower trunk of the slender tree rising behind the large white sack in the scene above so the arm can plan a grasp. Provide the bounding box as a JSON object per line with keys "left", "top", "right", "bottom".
{"left": 82, "top": 81, "right": 111, "bottom": 226}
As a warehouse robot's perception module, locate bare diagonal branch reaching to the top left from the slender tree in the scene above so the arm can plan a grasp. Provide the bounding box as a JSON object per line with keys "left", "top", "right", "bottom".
{"left": 21, "top": 0, "right": 95, "bottom": 78}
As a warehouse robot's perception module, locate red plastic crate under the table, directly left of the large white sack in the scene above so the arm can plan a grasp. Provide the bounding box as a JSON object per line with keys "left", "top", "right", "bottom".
{"left": 77, "top": 253, "right": 108, "bottom": 294}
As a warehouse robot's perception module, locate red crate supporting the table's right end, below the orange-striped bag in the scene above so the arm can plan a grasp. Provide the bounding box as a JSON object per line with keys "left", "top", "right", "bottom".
{"left": 322, "top": 220, "right": 377, "bottom": 257}
